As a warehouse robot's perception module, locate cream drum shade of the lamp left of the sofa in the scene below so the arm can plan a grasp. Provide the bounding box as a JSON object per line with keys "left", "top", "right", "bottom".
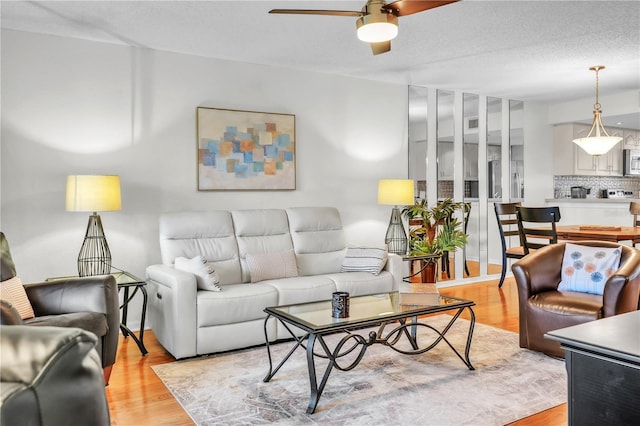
{"left": 66, "top": 175, "right": 122, "bottom": 212}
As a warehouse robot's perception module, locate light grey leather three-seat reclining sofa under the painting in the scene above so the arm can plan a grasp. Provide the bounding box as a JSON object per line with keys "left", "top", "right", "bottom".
{"left": 147, "top": 207, "right": 403, "bottom": 359}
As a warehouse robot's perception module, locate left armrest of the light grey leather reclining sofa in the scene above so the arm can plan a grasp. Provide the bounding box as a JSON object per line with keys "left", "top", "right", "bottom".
{"left": 147, "top": 265, "right": 198, "bottom": 359}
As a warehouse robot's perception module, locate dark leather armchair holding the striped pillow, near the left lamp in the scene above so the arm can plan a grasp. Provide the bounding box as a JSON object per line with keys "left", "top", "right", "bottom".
{"left": 0, "top": 232, "right": 120, "bottom": 384}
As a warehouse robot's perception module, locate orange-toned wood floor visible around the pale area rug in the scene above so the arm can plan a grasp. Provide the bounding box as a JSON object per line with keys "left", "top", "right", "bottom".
{"left": 107, "top": 279, "right": 567, "bottom": 426}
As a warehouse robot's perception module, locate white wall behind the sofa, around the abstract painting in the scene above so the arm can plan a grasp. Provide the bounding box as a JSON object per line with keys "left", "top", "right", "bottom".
{"left": 0, "top": 31, "right": 407, "bottom": 327}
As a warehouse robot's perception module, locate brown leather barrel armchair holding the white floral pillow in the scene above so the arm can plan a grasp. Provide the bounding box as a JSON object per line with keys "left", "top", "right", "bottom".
{"left": 511, "top": 241, "right": 640, "bottom": 358}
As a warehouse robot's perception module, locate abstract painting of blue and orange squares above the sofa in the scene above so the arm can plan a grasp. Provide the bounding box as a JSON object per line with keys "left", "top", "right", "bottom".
{"left": 196, "top": 107, "right": 296, "bottom": 191}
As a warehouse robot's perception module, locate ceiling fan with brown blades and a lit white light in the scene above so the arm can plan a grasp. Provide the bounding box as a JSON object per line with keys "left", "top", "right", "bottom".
{"left": 269, "top": 0, "right": 458, "bottom": 55}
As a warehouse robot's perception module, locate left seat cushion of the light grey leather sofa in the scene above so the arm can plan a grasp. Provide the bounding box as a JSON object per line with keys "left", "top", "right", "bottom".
{"left": 196, "top": 283, "right": 278, "bottom": 327}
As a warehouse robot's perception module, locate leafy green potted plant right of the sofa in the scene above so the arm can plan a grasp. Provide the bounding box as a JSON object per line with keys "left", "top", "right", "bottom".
{"left": 402, "top": 198, "right": 468, "bottom": 282}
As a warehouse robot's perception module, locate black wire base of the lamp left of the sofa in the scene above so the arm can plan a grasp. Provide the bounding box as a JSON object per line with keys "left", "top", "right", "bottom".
{"left": 78, "top": 212, "right": 111, "bottom": 277}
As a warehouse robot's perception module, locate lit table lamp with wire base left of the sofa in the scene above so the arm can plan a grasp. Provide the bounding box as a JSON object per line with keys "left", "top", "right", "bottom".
{"left": 66, "top": 175, "right": 122, "bottom": 277}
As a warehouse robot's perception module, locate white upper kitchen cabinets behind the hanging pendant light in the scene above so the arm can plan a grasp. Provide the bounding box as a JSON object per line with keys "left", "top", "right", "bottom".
{"left": 554, "top": 123, "right": 623, "bottom": 176}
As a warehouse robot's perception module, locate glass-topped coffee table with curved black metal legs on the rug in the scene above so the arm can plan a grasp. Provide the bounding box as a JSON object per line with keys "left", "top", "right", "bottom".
{"left": 263, "top": 292, "right": 475, "bottom": 414}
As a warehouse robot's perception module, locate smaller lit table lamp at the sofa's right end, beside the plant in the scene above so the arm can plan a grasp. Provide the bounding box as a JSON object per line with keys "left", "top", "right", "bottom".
{"left": 378, "top": 179, "right": 414, "bottom": 255}
